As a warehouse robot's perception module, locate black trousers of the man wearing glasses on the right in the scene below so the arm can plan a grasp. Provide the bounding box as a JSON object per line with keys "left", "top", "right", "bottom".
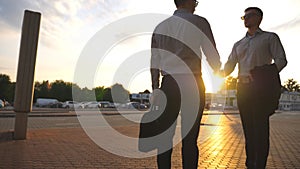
{"left": 237, "top": 83, "right": 270, "bottom": 169}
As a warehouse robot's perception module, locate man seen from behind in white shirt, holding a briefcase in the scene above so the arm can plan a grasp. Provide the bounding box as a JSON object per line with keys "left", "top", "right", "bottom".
{"left": 151, "top": 0, "right": 221, "bottom": 169}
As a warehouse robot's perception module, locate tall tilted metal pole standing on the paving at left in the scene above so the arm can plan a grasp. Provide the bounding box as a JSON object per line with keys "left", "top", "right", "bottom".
{"left": 14, "top": 10, "right": 41, "bottom": 140}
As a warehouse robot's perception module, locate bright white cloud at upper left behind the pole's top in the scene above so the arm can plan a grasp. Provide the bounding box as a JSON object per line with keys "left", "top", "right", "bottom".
{"left": 0, "top": 0, "right": 129, "bottom": 46}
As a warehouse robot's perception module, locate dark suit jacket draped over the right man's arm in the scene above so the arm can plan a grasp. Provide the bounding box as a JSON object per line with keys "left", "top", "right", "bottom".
{"left": 250, "top": 64, "right": 281, "bottom": 116}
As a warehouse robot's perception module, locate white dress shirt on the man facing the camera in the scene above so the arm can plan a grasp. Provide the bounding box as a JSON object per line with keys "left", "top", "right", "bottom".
{"left": 224, "top": 29, "right": 287, "bottom": 77}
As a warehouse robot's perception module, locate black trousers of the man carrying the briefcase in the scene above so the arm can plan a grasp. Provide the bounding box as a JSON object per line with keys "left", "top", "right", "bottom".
{"left": 157, "top": 75, "right": 205, "bottom": 169}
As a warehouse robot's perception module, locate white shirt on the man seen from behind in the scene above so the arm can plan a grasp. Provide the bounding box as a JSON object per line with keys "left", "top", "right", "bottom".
{"left": 151, "top": 10, "right": 221, "bottom": 74}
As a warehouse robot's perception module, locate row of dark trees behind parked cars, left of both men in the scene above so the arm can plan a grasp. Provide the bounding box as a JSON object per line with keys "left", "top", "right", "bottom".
{"left": 0, "top": 74, "right": 129, "bottom": 103}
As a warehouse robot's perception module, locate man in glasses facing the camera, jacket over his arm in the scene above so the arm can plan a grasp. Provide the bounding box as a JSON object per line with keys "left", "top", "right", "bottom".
{"left": 224, "top": 7, "right": 287, "bottom": 169}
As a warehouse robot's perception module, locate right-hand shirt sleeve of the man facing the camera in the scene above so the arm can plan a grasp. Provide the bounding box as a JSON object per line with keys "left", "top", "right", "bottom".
{"left": 270, "top": 33, "right": 287, "bottom": 72}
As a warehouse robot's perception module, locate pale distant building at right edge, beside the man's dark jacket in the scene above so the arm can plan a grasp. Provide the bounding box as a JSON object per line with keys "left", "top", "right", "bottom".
{"left": 278, "top": 92, "right": 300, "bottom": 111}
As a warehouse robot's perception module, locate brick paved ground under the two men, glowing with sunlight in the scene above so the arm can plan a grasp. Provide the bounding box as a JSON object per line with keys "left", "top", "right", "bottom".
{"left": 0, "top": 113, "right": 300, "bottom": 169}
